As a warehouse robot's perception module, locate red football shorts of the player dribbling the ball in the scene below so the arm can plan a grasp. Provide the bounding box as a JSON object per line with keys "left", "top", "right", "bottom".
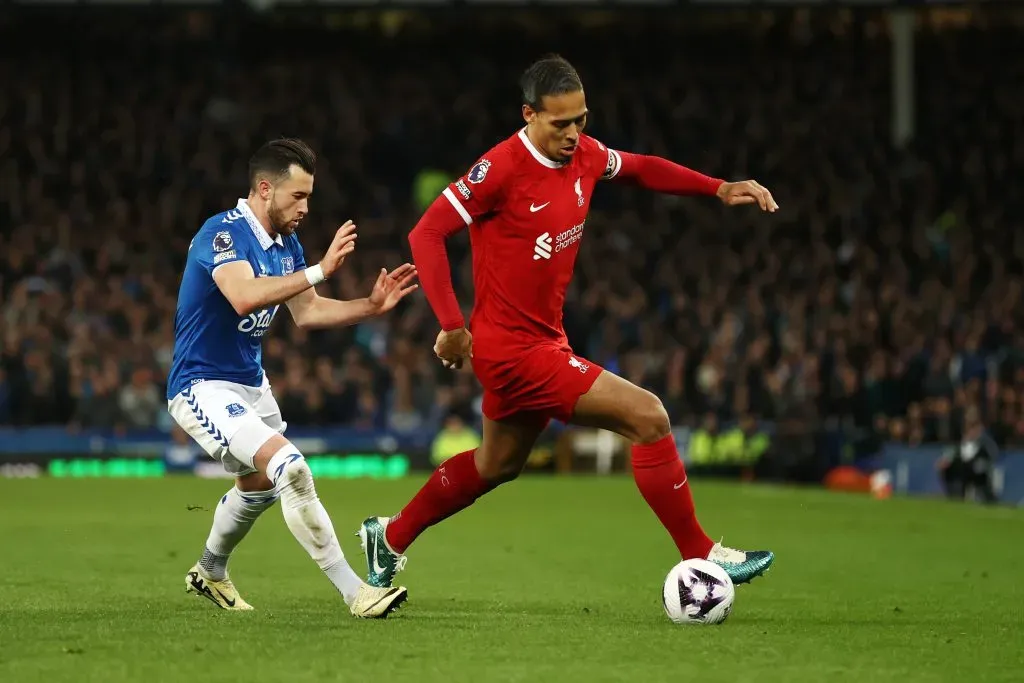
{"left": 473, "top": 345, "right": 604, "bottom": 423}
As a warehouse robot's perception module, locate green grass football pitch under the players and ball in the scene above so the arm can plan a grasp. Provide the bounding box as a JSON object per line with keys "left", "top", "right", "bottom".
{"left": 0, "top": 477, "right": 1024, "bottom": 683}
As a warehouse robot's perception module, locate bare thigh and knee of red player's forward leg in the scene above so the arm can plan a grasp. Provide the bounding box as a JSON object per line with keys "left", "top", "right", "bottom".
{"left": 569, "top": 372, "right": 672, "bottom": 443}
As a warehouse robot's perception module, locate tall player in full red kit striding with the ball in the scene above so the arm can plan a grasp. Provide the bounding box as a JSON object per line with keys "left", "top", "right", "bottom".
{"left": 359, "top": 56, "right": 778, "bottom": 586}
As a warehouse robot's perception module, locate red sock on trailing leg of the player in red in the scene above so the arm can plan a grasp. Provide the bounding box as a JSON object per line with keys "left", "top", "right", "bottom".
{"left": 384, "top": 451, "right": 491, "bottom": 553}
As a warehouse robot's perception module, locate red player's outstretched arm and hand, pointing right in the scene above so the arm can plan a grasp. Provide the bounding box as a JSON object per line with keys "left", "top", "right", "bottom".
{"left": 601, "top": 145, "right": 778, "bottom": 212}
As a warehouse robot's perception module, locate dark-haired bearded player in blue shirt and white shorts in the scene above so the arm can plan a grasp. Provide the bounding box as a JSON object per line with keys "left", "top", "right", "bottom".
{"left": 167, "top": 139, "right": 417, "bottom": 618}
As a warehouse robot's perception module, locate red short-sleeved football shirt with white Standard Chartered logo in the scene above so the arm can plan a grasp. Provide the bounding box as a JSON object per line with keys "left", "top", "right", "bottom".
{"left": 443, "top": 129, "right": 622, "bottom": 356}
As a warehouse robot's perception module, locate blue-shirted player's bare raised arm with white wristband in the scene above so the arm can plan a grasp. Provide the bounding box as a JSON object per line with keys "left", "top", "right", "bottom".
{"left": 213, "top": 220, "right": 355, "bottom": 315}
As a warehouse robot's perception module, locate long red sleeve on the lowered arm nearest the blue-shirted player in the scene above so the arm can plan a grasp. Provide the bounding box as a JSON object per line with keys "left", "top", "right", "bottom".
{"left": 409, "top": 149, "right": 511, "bottom": 331}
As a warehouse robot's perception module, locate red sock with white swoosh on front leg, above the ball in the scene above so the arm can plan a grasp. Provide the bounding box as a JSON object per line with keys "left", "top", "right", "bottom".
{"left": 630, "top": 434, "right": 715, "bottom": 560}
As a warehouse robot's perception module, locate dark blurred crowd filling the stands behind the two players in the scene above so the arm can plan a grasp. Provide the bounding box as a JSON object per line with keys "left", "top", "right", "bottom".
{"left": 0, "top": 12, "right": 1024, "bottom": 444}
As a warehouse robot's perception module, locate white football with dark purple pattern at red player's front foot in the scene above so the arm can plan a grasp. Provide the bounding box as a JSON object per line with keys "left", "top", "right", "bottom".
{"left": 662, "top": 560, "right": 736, "bottom": 624}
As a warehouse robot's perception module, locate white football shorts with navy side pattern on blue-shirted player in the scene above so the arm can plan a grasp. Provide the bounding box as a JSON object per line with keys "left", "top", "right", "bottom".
{"left": 167, "top": 375, "right": 288, "bottom": 476}
